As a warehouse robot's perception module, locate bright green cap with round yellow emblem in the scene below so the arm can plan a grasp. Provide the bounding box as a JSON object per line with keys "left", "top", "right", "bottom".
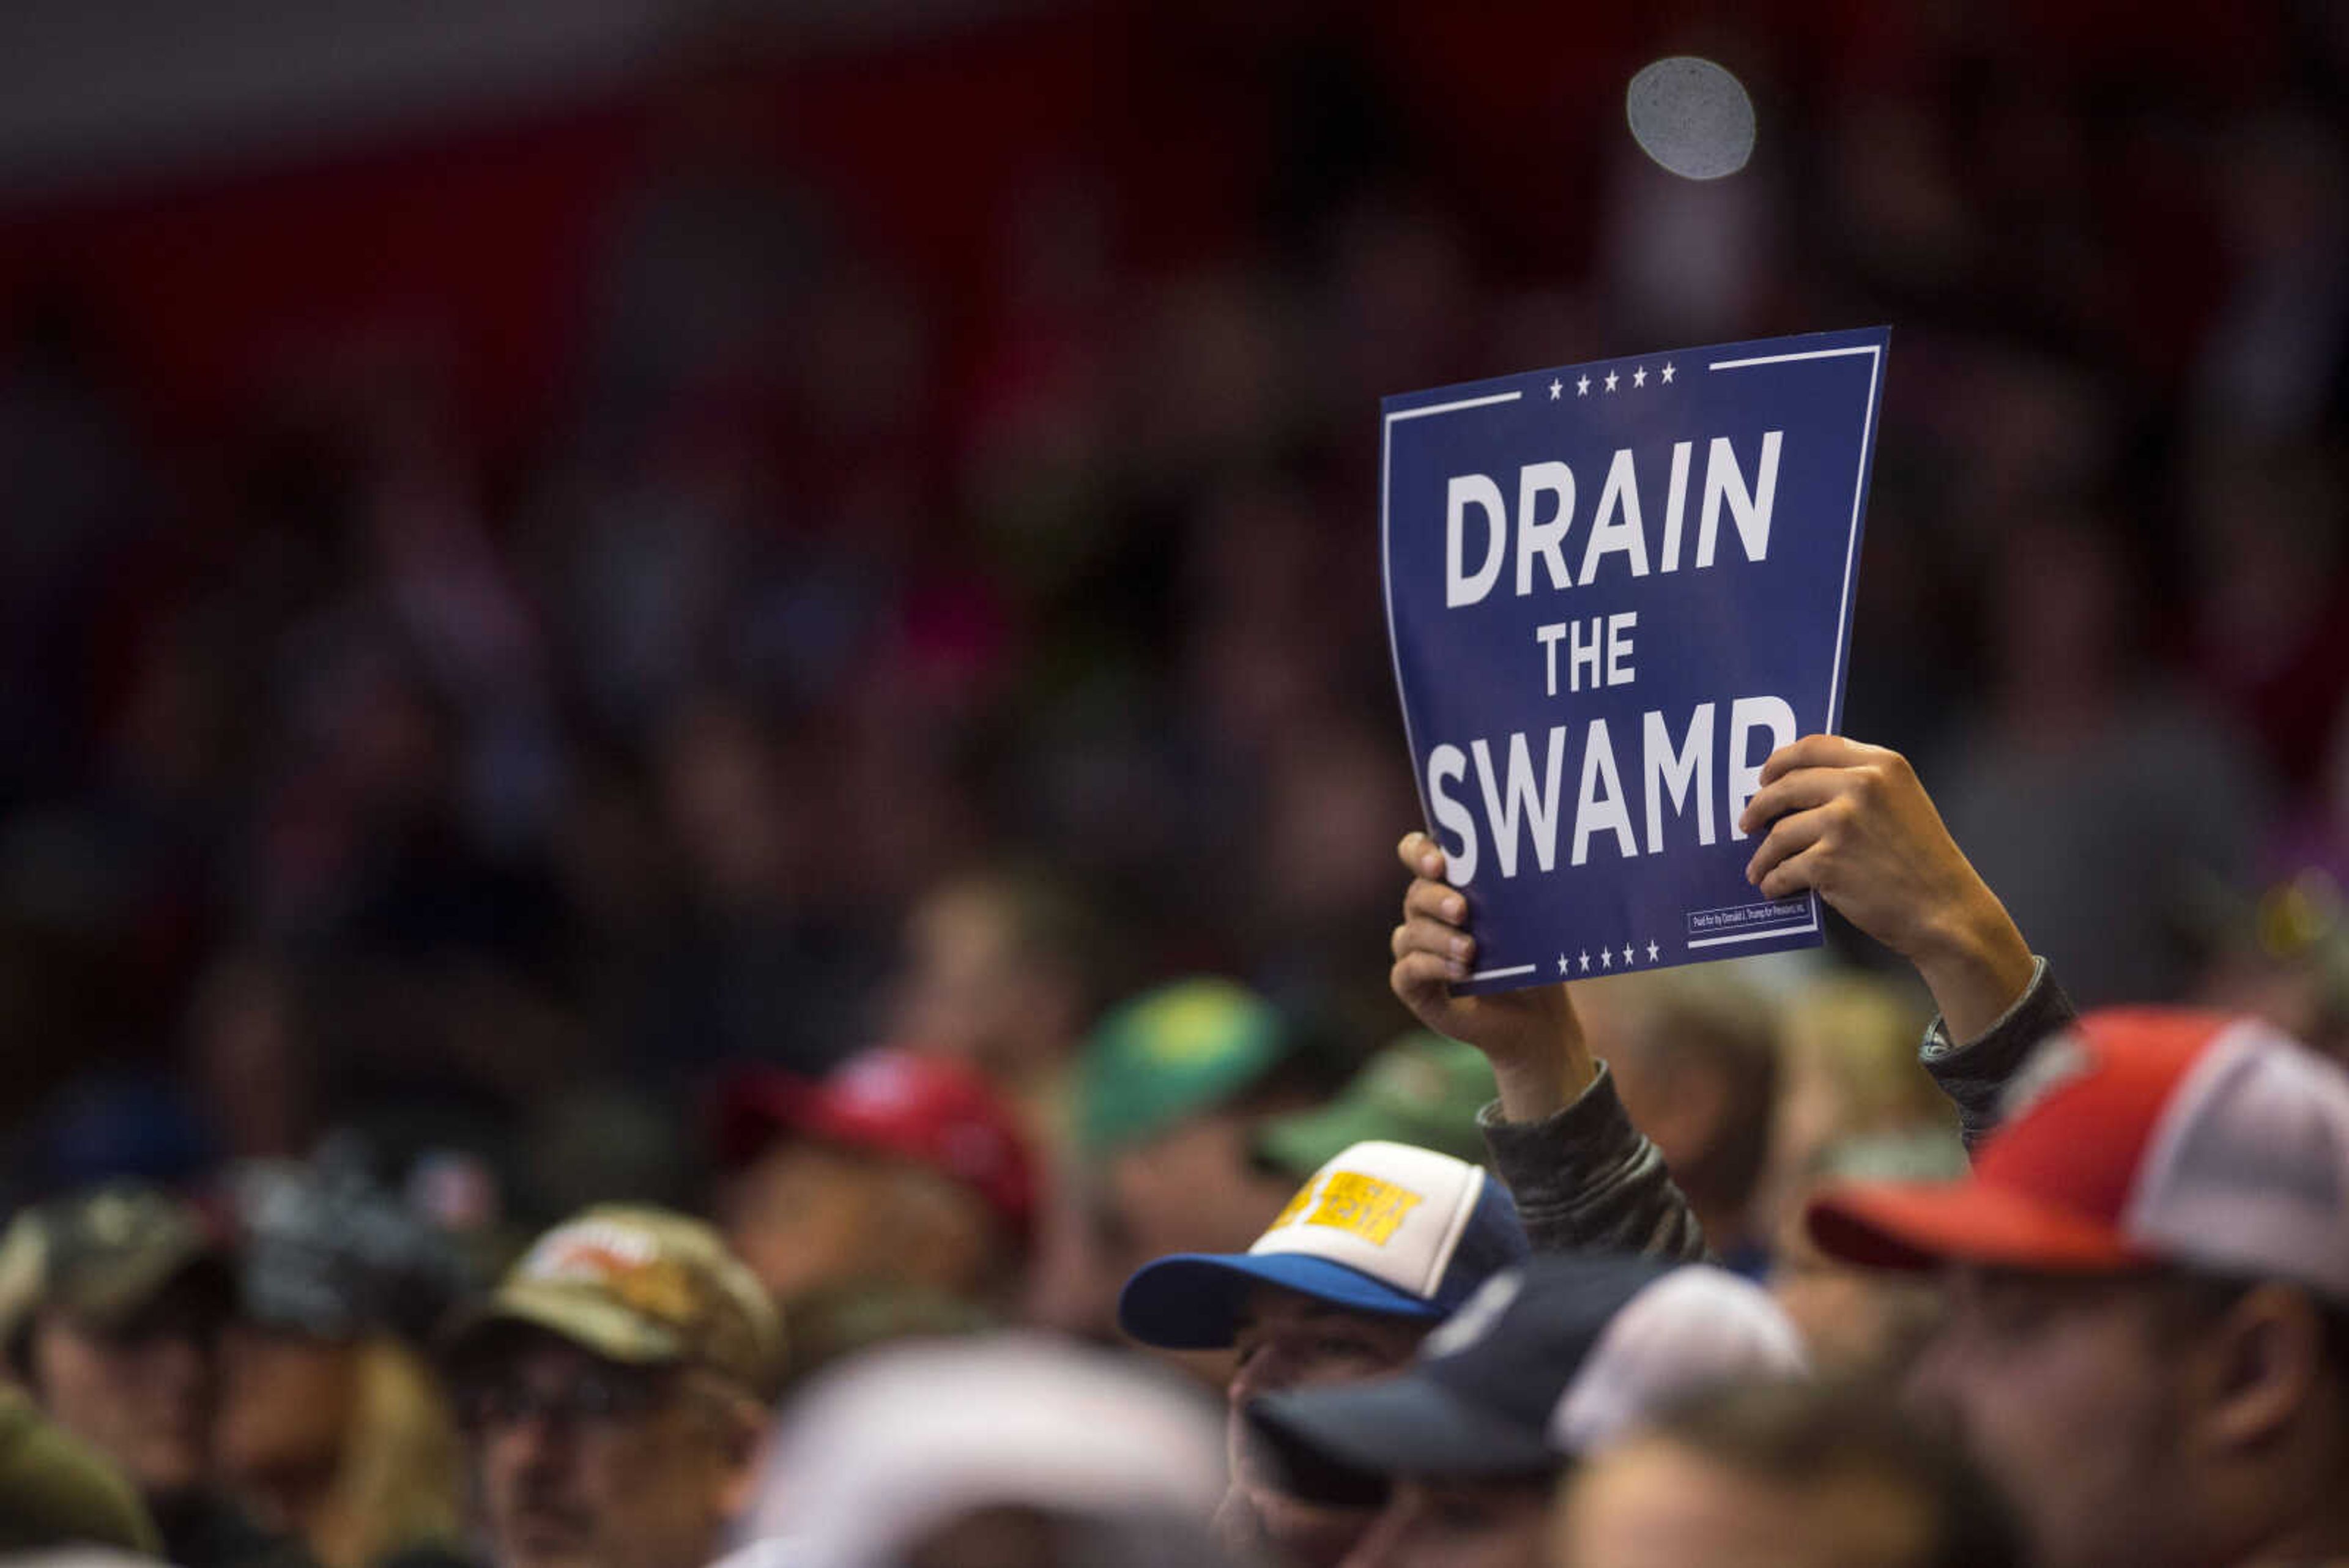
{"left": 1076, "top": 978, "right": 1294, "bottom": 1154}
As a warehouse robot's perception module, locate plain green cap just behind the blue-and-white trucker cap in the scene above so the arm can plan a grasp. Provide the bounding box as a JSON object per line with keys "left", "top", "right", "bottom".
{"left": 1256, "top": 1032, "right": 1494, "bottom": 1180}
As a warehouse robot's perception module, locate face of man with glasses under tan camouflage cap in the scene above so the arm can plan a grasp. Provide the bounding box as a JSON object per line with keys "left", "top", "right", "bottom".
{"left": 462, "top": 1336, "right": 756, "bottom": 1568}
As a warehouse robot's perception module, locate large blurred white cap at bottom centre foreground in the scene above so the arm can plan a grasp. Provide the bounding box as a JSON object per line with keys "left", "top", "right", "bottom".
{"left": 738, "top": 1333, "right": 1224, "bottom": 1568}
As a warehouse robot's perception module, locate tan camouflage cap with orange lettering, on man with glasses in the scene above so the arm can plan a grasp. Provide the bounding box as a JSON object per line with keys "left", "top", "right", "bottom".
{"left": 447, "top": 1203, "right": 782, "bottom": 1399}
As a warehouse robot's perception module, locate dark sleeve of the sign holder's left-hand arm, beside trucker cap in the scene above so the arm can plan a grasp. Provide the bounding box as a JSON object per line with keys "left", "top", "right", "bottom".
{"left": 1477, "top": 1063, "right": 1705, "bottom": 1260}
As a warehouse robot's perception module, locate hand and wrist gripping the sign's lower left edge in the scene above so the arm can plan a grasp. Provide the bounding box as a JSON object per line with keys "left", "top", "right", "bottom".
{"left": 1388, "top": 832, "right": 1595, "bottom": 1121}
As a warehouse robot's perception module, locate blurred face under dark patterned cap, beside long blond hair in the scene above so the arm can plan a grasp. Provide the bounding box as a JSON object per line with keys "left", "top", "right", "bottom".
{"left": 218, "top": 1323, "right": 360, "bottom": 1486}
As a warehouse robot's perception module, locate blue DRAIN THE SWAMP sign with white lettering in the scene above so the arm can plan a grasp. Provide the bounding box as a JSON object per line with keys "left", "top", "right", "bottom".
{"left": 1379, "top": 327, "right": 1891, "bottom": 992}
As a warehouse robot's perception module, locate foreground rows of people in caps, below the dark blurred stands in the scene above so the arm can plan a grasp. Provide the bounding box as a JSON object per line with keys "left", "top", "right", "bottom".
{"left": 0, "top": 736, "right": 2349, "bottom": 1568}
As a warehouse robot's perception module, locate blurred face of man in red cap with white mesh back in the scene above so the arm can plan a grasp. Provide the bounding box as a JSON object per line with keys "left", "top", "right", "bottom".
{"left": 1912, "top": 1267, "right": 2192, "bottom": 1568}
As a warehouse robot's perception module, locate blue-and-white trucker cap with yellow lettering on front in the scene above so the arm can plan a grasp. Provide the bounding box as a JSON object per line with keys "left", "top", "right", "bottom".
{"left": 1118, "top": 1142, "right": 1529, "bottom": 1350}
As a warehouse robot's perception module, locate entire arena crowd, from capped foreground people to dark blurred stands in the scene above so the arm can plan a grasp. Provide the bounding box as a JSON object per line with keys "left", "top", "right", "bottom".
{"left": 0, "top": 5, "right": 2349, "bottom": 1568}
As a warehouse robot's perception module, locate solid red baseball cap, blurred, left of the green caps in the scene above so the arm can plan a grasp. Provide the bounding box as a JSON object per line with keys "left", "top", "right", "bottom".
{"left": 714, "top": 1046, "right": 1036, "bottom": 1232}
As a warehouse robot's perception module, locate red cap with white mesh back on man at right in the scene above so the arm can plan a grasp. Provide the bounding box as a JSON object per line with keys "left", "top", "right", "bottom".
{"left": 1804, "top": 1008, "right": 2349, "bottom": 1300}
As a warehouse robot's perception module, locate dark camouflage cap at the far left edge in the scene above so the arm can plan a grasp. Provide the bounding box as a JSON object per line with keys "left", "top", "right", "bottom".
{"left": 0, "top": 1183, "right": 235, "bottom": 1356}
